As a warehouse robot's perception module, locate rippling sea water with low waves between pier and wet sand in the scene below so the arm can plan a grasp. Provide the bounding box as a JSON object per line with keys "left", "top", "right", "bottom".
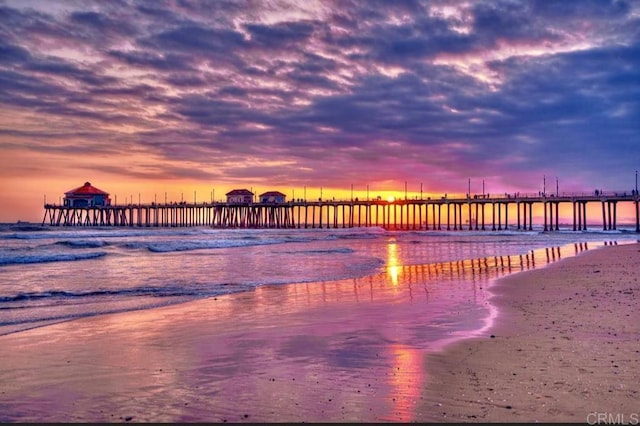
{"left": 0, "top": 224, "right": 638, "bottom": 335}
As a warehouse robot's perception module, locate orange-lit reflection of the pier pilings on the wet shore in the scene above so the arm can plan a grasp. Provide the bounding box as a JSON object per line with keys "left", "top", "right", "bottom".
{"left": 294, "top": 241, "right": 618, "bottom": 302}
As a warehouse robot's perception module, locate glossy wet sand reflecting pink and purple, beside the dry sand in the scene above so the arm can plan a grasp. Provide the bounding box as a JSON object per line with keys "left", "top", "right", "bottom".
{"left": 0, "top": 260, "right": 500, "bottom": 422}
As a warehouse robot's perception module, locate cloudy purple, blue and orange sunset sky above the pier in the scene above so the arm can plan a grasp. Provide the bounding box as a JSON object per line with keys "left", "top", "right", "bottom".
{"left": 0, "top": 0, "right": 640, "bottom": 222}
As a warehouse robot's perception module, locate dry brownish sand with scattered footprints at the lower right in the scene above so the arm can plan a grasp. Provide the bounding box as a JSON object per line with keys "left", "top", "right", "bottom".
{"left": 418, "top": 243, "right": 640, "bottom": 424}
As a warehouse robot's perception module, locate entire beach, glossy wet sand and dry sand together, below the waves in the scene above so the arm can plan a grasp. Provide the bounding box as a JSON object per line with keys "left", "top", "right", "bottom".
{"left": 0, "top": 236, "right": 640, "bottom": 422}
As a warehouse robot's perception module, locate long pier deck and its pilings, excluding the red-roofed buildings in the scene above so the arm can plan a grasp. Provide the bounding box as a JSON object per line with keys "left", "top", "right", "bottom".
{"left": 42, "top": 192, "right": 640, "bottom": 232}
